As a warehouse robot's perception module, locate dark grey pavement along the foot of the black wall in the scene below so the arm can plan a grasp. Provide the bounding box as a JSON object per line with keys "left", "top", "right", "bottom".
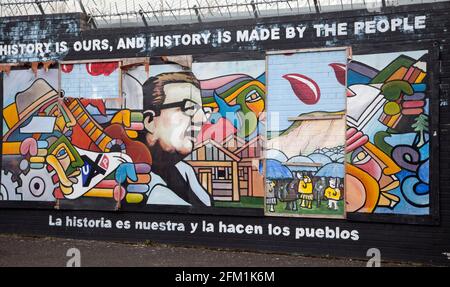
{"left": 0, "top": 234, "right": 418, "bottom": 267}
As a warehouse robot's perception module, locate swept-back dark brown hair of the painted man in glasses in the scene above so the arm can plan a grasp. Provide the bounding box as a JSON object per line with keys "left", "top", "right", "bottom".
{"left": 142, "top": 72, "right": 200, "bottom": 111}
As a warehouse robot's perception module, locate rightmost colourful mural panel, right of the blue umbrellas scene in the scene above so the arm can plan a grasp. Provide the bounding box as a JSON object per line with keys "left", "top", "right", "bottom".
{"left": 346, "top": 51, "right": 430, "bottom": 215}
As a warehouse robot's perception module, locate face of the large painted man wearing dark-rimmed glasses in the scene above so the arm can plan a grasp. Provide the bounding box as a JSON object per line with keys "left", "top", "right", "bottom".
{"left": 147, "top": 83, "right": 206, "bottom": 155}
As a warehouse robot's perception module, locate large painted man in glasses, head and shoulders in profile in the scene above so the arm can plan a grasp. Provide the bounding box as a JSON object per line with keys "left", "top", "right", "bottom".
{"left": 143, "top": 72, "right": 212, "bottom": 207}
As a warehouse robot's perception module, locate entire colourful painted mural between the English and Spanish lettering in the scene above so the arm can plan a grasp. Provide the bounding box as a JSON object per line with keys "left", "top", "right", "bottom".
{"left": 0, "top": 50, "right": 430, "bottom": 218}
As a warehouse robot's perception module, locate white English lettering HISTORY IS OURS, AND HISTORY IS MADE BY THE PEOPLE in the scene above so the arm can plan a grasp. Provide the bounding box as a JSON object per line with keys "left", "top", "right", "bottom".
{"left": 0, "top": 15, "right": 426, "bottom": 58}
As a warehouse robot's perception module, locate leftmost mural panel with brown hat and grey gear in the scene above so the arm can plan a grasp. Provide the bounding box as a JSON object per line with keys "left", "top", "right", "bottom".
{"left": 0, "top": 69, "right": 59, "bottom": 201}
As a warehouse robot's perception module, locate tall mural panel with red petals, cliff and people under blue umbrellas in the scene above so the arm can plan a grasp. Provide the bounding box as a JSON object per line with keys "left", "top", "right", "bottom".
{"left": 266, "top": 50, "right": 347, "bottom": 217}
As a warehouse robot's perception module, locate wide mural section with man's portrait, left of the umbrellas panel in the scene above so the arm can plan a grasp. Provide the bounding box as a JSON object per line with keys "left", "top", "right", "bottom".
{"left": 1, "top": 61, "right": 265, "bottom": 210}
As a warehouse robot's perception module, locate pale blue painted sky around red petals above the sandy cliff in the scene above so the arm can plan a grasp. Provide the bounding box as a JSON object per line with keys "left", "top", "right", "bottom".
{"left": 267, "top": 50, "right": 347, "bottom": 130}
